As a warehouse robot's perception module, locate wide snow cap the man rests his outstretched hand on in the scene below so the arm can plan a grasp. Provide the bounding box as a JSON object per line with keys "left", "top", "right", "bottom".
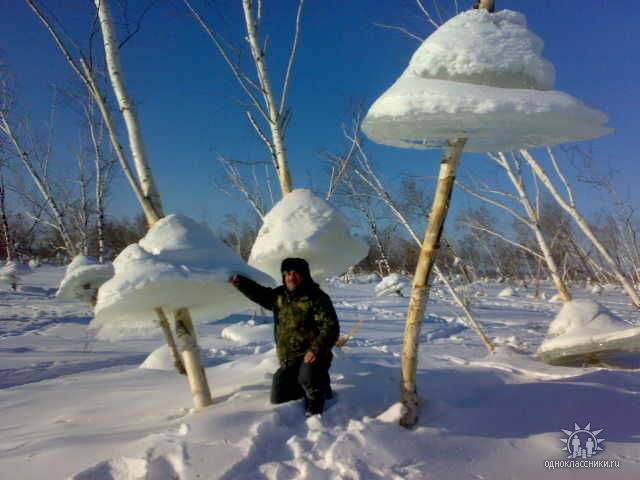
{"left": 91, "top": 215, "right": 273, "bottom": 338}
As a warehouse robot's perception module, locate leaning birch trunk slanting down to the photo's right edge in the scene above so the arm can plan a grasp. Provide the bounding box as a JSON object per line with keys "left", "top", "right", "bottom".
{"left": 520, "top": 150, "right": 640, "bottom": 308}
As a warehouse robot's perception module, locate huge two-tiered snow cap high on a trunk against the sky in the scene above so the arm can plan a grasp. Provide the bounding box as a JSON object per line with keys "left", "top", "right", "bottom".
{"left": 362, "top": 10, "right": 612, "bottom": 152}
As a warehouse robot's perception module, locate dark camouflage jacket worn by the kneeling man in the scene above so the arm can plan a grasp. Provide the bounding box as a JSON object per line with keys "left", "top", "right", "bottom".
{"left": 232, "top": 276, "right": 340, "bottom": 366}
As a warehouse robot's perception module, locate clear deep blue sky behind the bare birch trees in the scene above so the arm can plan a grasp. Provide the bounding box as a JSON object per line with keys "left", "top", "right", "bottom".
{"left": 0, "top": 0, "right": 640, "bottom": 232}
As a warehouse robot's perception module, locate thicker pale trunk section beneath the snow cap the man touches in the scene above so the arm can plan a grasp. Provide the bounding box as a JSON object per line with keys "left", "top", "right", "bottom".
{"left": 173, "top": 308, "right": 213, "bottom": 408}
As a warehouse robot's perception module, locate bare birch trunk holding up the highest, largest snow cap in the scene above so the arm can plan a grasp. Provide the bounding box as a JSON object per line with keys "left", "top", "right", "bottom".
{"left": 400, "top": 138, "right": 467, "bottom": 428}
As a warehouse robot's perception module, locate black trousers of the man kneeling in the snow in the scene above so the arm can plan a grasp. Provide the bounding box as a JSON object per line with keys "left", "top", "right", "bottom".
{"left": 271, "top": 354, "right": 333, "bottom": 403}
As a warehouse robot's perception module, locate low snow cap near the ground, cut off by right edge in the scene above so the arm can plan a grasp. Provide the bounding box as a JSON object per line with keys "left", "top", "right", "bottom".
{"left": 536, "top": 298, "right": 640, "bottom": 361}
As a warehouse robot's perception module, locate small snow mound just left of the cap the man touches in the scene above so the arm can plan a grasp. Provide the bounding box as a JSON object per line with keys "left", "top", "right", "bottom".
{"left": 56, "top": 255, "right": 114, "bottom": 303}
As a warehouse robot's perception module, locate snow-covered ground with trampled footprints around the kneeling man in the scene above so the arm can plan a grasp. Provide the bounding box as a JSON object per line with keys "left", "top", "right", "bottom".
{"left": 0, "top": 266, "right": 640, "bottom": 480}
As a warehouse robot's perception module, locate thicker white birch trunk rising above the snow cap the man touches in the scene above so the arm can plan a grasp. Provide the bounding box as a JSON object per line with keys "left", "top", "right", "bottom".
{"left": 95, "top": 0, "right": 164, "bottom": 226}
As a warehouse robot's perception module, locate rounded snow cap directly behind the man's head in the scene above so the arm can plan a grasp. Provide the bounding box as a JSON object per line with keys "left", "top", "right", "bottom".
{"left": 249, "top": 189, "right": 369, "bottom": 283}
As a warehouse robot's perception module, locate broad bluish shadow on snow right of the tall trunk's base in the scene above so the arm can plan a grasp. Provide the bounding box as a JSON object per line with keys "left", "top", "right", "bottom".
{"left": 418, "top": 369, "right": 640, "bottom": 443}
